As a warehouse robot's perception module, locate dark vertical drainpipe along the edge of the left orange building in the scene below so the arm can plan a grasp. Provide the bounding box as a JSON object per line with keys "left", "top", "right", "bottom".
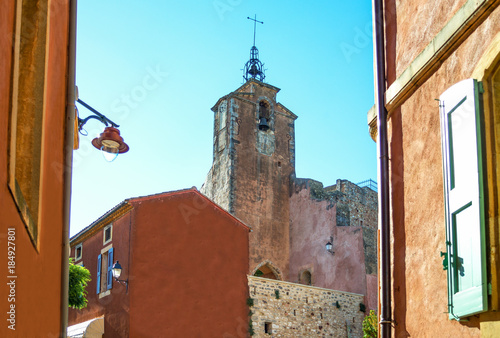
{"left": 60, "top": 0, "right": 76, "bottom": 338}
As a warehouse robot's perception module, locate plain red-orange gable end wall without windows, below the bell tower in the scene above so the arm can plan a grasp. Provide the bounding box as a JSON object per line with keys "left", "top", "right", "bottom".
{"left": 129, "top": 191, "right": 248, "bottom": 337}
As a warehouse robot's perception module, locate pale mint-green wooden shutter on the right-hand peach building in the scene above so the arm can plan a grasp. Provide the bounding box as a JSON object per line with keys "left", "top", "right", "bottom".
{"left": 440, "top": 79, "right": 488, "bottom": 319}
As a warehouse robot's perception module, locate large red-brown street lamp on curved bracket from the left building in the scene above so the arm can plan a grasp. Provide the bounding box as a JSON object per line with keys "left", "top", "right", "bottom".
{"left": 76, "top": 98, "right": 129, "bottom": 162}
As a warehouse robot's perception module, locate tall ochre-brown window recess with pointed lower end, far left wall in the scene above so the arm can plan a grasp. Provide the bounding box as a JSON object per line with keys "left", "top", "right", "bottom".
{"left": 9, "top": 1, "right": 49, "bottom": 247}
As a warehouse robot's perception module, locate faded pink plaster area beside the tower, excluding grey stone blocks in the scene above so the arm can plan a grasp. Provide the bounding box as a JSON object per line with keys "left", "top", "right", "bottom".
{"left": 290, "top": 185, "right": 370, "bottom": 298}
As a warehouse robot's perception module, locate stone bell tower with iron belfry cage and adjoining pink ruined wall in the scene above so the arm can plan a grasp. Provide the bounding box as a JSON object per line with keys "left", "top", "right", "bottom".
{"left": 200, "top": 40, "right": 377, "bottom": 309}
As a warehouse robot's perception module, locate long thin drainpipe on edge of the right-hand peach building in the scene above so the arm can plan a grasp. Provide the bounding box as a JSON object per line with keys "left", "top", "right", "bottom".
{"left": 373, "top": 0, "right": 392, "bottom": 338}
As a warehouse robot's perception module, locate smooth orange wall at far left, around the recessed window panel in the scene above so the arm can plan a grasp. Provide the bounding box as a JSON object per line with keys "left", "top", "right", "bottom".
{"left": 0, "top": 0, "right": 69, "bottom": 337}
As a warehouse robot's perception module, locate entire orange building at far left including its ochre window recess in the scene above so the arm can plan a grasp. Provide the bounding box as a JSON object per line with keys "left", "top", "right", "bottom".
{"left": 0, "top": 0, "right": 76, "bottom": 337}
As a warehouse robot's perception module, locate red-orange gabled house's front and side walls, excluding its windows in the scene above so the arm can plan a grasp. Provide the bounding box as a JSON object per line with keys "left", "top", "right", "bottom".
{"left": 69, "top": 189, "right": 249, "bottom": 338}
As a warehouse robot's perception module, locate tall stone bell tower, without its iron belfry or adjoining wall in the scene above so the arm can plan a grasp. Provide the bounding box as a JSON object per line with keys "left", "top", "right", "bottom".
{"left": 201, "top": 74, "right": 297, "bottom": 280}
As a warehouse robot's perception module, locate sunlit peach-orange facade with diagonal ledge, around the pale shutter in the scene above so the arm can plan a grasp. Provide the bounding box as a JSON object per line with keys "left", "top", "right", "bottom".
{"left": 368, "top": 0, "right": 500, "bottom": 337}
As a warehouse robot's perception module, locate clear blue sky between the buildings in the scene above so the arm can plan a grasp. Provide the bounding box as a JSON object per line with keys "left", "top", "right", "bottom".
{"left": 71, "top": 0, "right": 377, "bottom": 235}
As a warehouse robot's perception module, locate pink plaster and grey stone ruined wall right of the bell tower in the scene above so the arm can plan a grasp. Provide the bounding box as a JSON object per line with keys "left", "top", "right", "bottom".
{"left": 289, "top": 179, "right": 377, "bottom": 309}
